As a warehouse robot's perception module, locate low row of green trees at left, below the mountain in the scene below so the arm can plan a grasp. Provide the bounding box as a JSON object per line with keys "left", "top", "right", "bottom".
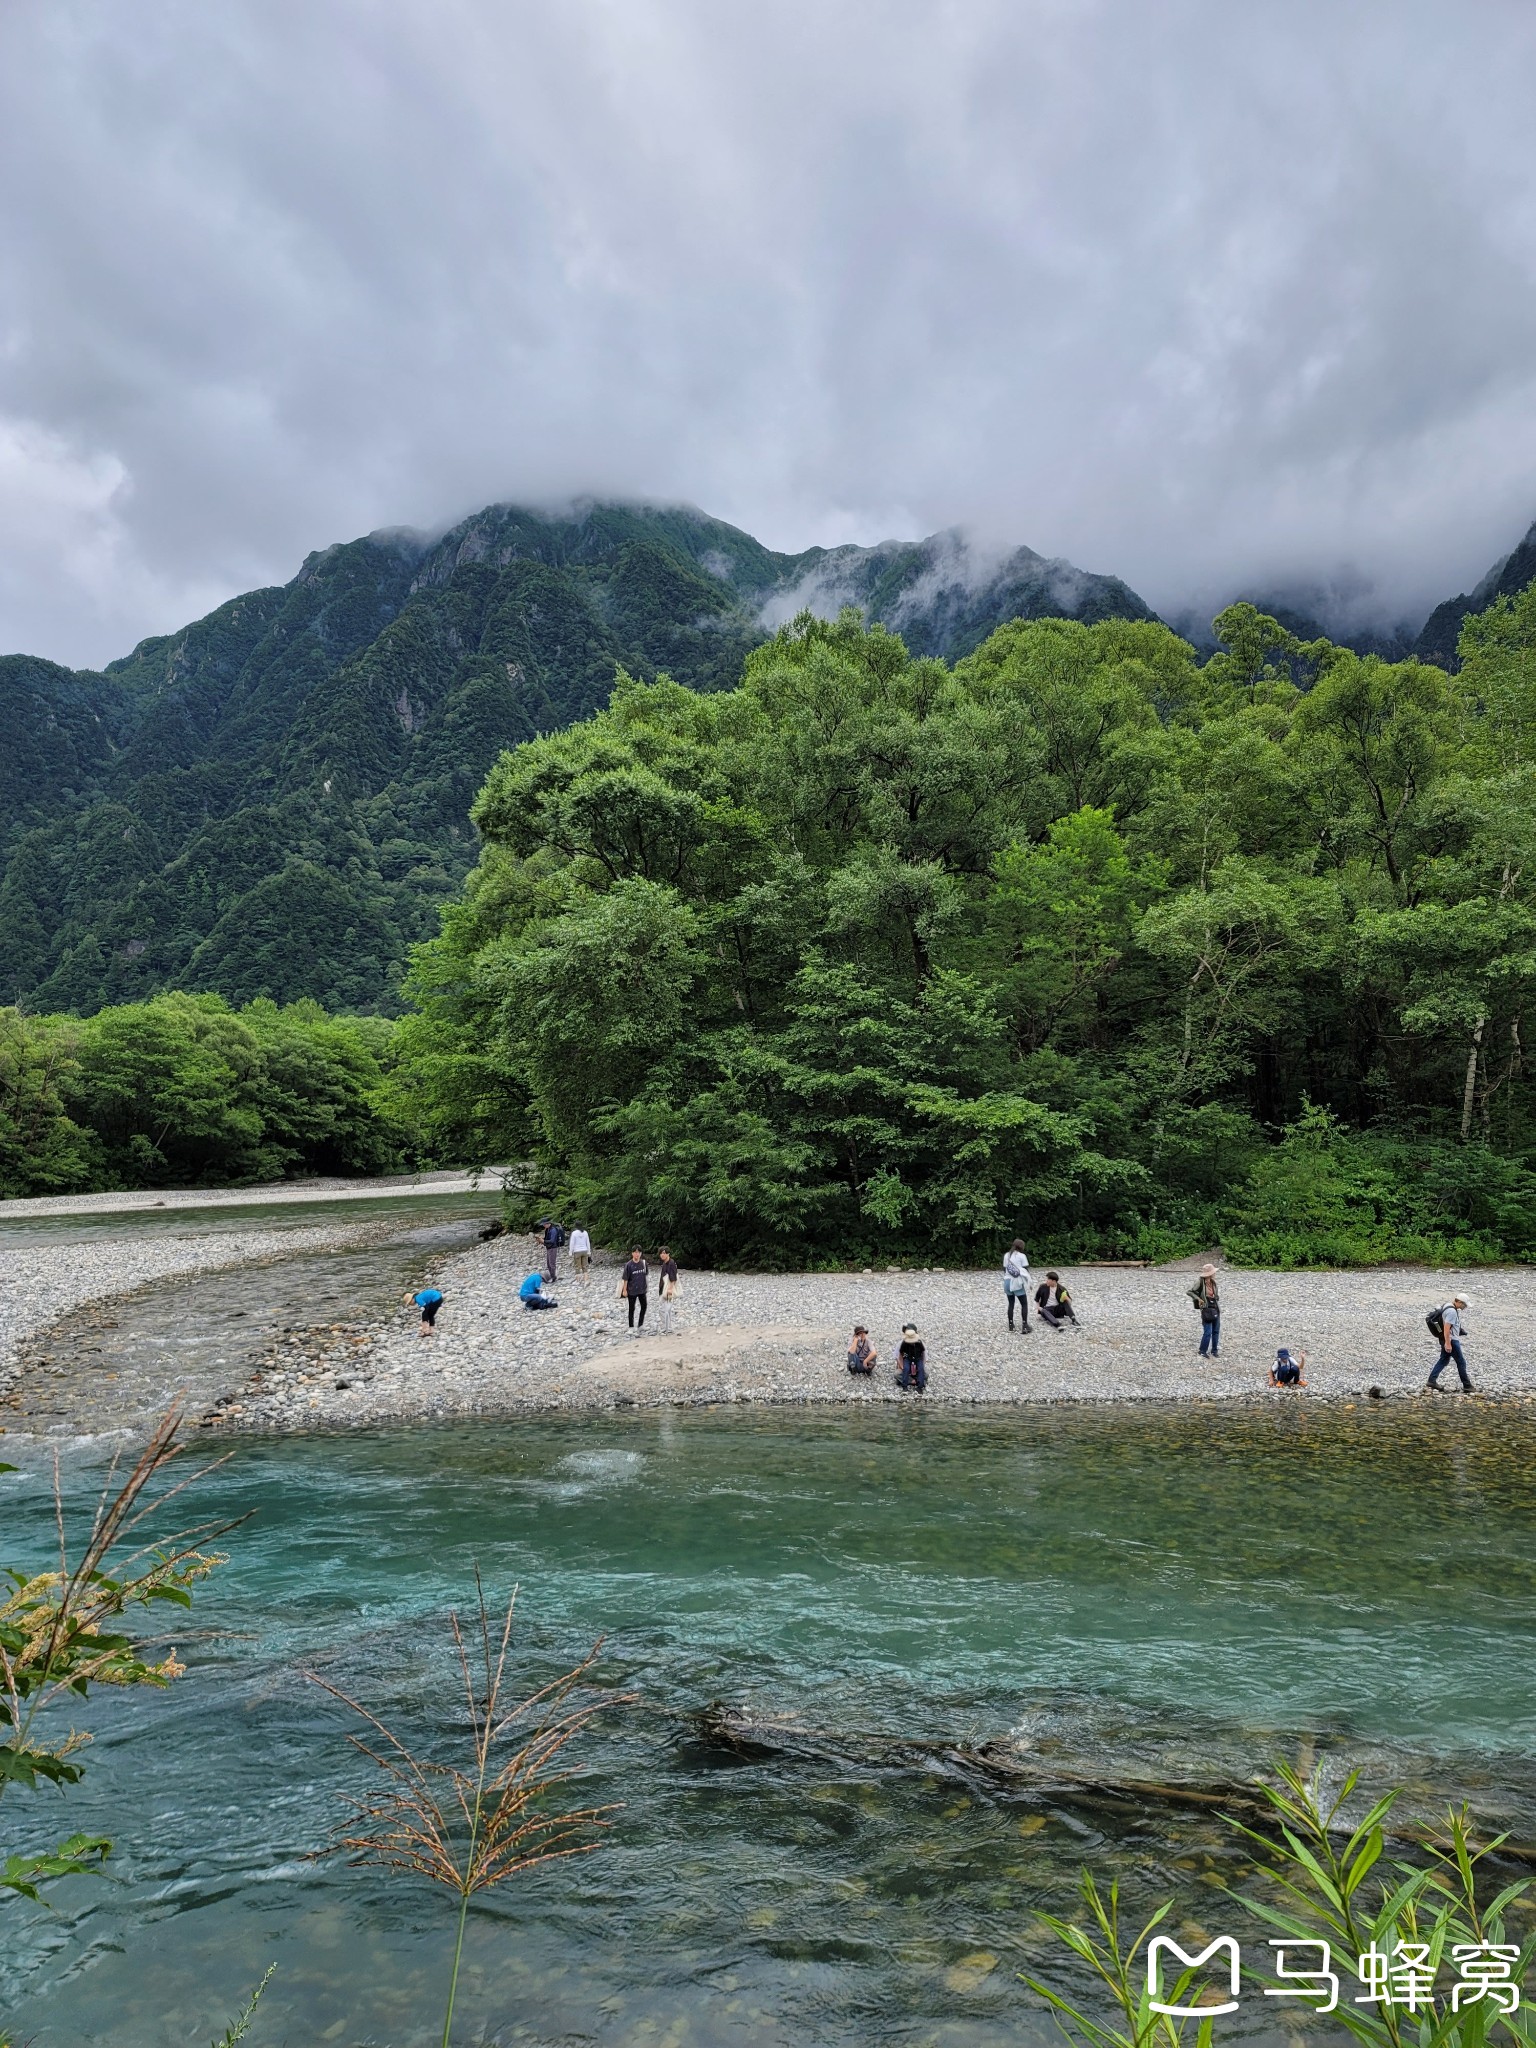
{"left": 0, "top": 995, "right": 406, "bottom": 1196}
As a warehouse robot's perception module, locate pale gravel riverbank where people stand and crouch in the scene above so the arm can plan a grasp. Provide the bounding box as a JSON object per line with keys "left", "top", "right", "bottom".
{"left": 211, "top": 1237, "right": 1536, "bottom": 1430}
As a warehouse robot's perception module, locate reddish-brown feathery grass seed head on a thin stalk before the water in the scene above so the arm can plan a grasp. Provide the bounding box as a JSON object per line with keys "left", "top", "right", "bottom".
{"left": 309, "top": 1571, "right": 633, "bottom": 2048}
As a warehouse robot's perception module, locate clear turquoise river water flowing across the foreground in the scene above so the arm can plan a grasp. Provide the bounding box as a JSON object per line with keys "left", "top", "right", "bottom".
{"left": 0, "top": 1403, "right": 1536, "bottom": 2048}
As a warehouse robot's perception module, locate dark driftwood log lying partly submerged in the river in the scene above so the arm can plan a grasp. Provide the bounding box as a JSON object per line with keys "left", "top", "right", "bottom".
{"left": 694, "top": 1700, "right": 1536, "bottom": 1866}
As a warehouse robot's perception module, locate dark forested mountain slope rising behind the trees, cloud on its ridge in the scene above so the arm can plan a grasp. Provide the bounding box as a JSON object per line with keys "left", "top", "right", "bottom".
{"left": 0, "top": 504, "right": 1151, "bottom": 1012}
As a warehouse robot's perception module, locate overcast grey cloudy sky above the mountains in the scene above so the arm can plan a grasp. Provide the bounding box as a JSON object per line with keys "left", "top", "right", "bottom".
{"left": 0, "top": 0, "right": 1536, "bottom": 664}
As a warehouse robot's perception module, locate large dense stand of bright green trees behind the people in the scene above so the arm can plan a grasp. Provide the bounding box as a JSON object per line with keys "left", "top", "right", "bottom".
{"left": 409, "top": 590, "right": 1536, "bottom": 1266}
